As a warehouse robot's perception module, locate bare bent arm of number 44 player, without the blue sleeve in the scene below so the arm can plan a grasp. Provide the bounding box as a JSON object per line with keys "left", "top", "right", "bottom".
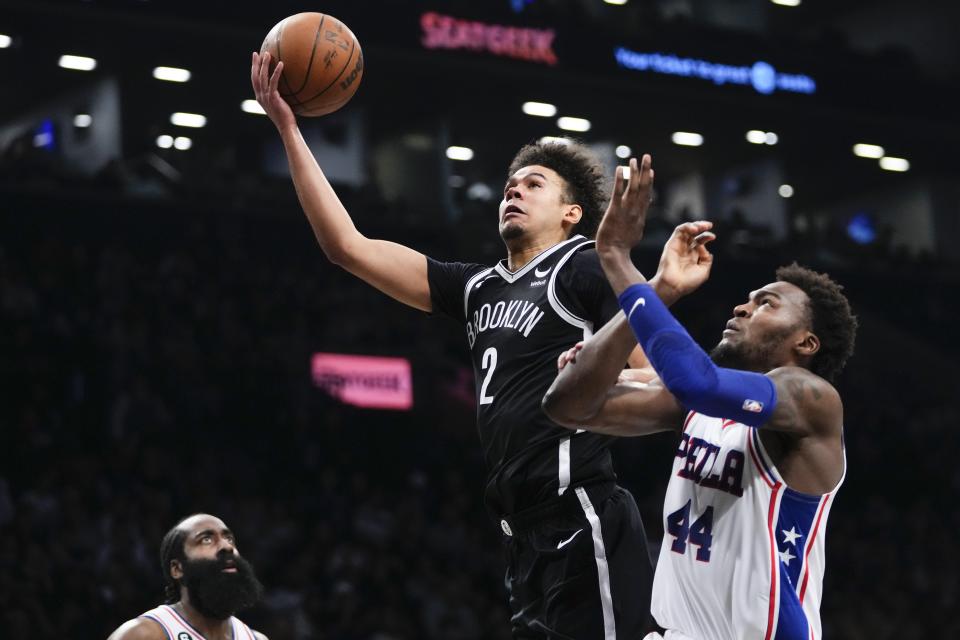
{"left": 543, "top": 313, "right": 683, "bottom": 436}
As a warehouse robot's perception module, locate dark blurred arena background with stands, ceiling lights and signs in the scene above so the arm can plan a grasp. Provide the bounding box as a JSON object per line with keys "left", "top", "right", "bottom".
{"left": 0, "top": 0, "right": 960, "bottom": 640}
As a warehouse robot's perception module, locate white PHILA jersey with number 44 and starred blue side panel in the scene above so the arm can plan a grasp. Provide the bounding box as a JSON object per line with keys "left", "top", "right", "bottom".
{"left": 652, "top": 412, "right": 845, "bottom": 640}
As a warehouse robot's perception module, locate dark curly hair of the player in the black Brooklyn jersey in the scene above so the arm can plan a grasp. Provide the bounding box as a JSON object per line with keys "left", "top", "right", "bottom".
{"left": 507, "top": 141, "right": 609, "bottom": 238}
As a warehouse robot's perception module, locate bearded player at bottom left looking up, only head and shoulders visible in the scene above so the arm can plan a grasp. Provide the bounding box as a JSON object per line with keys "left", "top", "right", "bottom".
{"left": 107, "top": 513, "right": 267, "bottom": 640}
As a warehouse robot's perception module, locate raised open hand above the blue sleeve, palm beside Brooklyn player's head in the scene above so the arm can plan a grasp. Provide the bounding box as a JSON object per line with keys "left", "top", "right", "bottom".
{"left": 597, "top": 154, "right": 653, "bottom": 253}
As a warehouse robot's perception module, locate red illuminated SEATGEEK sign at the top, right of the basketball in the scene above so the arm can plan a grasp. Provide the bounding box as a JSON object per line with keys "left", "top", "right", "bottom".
{"left": 420, "top": 11, "right": 557, "bottom": 65}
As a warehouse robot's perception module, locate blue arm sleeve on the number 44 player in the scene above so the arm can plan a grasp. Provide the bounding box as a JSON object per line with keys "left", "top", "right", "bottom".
{"left": 619, "top": 284, "right": 777, "bottom": 427}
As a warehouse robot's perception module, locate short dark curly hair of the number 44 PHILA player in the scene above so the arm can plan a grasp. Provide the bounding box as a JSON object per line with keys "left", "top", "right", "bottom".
{"left": 777, "top": 262, "right": 858, "bottom": 382}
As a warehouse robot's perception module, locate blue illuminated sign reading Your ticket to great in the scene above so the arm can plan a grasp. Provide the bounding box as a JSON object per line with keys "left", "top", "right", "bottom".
{"left": 613, "top": 47, "right": 817, "bottom": 95}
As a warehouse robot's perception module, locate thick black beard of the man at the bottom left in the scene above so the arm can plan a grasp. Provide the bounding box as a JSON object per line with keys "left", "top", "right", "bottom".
{"left": 181, "top": 552, "right": 263, "bottom": 620}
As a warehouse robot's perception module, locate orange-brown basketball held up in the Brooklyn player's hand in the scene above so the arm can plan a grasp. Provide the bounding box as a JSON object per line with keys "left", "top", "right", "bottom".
{"left": 260, "top": 12, "right": 363, "bottom": 116}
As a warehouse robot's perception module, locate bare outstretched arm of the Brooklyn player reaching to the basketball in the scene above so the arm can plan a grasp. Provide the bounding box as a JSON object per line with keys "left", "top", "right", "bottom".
{"left": 250, "top": 53, "right": 431, "bottom": 311}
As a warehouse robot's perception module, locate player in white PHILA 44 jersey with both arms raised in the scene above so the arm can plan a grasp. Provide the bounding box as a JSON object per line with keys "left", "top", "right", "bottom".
{"left": 544, "top": 156, "right": 857, "bottom": 640}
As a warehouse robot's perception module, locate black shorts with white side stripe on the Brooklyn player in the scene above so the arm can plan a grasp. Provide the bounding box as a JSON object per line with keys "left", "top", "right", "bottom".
{"left": 501, "top": 485, "right": 655, "bottom": 640}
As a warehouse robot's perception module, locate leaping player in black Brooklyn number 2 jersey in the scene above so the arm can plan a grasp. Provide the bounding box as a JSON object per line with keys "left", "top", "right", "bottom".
{"left": 251, "top": 53, "right": 672, "bottom": 640}
